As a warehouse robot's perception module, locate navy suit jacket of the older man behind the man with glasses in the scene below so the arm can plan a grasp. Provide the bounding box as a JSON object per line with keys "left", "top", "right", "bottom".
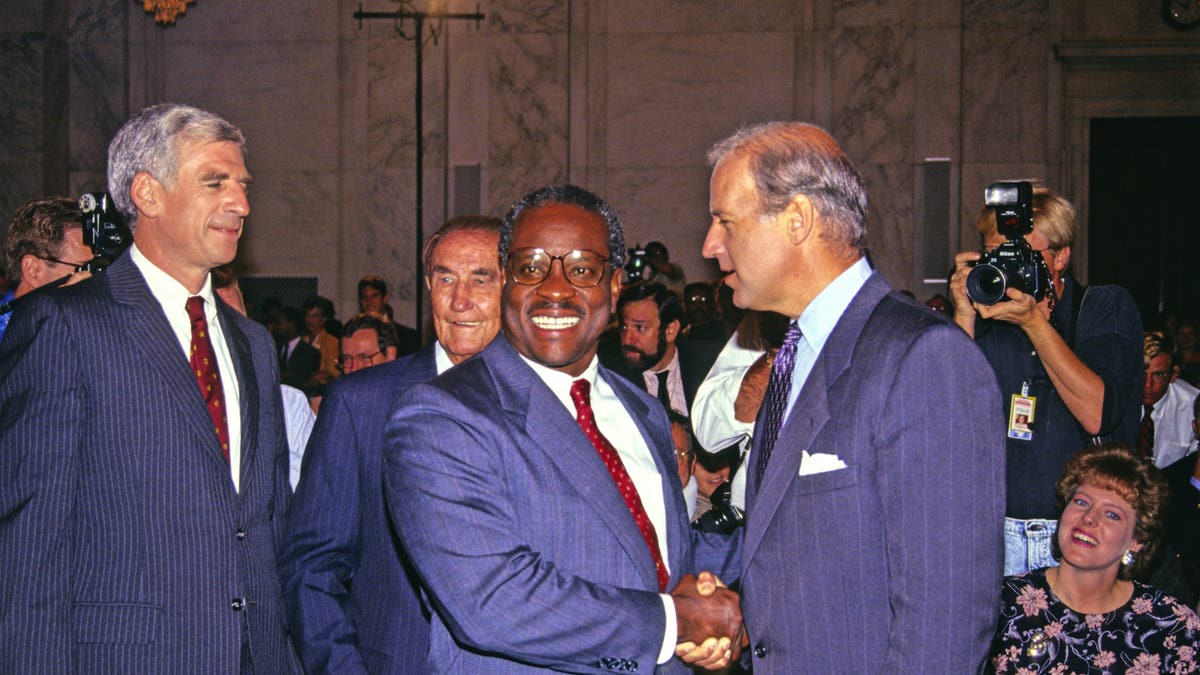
{"left": 280, "top": 345, "right": 437, "bottom": 674}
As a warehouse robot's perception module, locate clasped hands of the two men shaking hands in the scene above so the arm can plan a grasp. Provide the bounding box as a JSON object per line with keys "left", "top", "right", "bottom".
{"left": 671, "top": 572, "right": 750, "bottom": 670}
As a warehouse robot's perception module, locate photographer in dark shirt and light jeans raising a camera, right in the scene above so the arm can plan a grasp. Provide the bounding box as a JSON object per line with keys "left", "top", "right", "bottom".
{"left": 950, "top": 183, "right": 1141, "bottom": 575}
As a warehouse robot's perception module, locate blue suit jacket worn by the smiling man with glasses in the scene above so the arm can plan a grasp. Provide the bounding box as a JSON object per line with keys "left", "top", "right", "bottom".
{"left": 384, "top": 335, "right": 737, "bottom": 674}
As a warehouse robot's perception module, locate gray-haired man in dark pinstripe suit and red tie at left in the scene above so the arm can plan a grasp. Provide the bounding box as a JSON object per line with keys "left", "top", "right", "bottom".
{"left": 0, "top": 104, "right": 298, "bottom": 674}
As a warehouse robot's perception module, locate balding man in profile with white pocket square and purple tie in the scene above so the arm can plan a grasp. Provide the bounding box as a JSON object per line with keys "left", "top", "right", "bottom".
{"left": 703, "top": 123, "right": 1004, "bottom": 675}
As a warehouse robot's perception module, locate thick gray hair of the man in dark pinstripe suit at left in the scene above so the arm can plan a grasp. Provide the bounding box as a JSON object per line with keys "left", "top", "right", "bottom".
{"left": 108, "top": 103, "right": 246, "bottom": 231}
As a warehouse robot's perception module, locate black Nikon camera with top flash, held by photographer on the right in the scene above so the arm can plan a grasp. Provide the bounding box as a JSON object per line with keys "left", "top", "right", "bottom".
{"left": 967, "top": 180, "right": 1050, "bottom": 305}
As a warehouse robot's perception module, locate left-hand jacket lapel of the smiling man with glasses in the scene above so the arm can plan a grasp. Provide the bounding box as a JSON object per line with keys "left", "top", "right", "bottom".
{"left": 487, "top": 338, "right": 659, "bottom": 589}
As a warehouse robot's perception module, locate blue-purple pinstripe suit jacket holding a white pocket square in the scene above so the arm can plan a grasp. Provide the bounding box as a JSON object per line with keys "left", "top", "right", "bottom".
{"left": 742, "top": 274, "right": 1004, "bottom": 675}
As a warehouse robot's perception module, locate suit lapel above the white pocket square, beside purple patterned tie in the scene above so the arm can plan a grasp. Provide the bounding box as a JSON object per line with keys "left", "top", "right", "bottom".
{"left": 742, "top": 273, "right": 889, "bottom": 569}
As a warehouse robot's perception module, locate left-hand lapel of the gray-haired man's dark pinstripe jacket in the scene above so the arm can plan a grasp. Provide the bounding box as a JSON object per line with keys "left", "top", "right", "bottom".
{"left": 104, "top": 255, "right": 238, "bottom": 470}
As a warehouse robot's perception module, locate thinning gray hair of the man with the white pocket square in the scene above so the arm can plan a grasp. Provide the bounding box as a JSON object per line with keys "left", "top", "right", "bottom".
{"left": 708, "top": 121, "right": 866, "bottom": 252}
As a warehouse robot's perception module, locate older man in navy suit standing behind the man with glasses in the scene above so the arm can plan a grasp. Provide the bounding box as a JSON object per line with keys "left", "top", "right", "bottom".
{"left": 280, "top": 216, "right": 500, "bottom": 675}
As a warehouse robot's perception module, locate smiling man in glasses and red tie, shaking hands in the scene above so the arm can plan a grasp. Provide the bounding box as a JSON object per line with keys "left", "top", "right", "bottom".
{"left": 384, "top": 185, "right": 740, "bottom": 674}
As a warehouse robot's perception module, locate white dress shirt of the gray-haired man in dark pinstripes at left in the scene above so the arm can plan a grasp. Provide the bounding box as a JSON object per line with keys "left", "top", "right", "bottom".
{"left": 130, "top": 244, "right": 241, "bottom": 490}
